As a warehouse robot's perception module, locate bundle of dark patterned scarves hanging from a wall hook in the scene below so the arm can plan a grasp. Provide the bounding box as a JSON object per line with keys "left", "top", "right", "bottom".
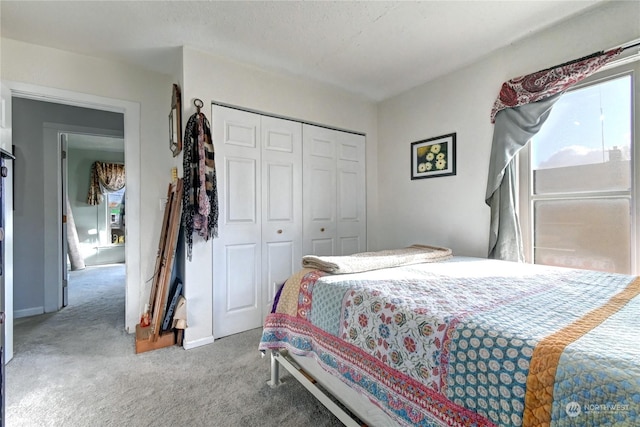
{"left": 182, "top": 113, "right": 218, "bottom": 261}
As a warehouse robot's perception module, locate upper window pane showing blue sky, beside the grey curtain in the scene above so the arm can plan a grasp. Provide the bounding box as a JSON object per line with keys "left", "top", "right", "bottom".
{"left": 531, "top": 76, "right": 632, "bottom": 194}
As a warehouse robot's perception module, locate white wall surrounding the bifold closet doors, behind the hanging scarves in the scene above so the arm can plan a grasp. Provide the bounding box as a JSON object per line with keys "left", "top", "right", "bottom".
{"left": 181, "top": 48, "right": 378, "bottom": 348}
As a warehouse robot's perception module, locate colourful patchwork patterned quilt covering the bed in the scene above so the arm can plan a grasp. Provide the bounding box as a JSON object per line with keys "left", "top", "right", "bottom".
{"left": 259, "top": 257, "right": 640, "bottom": 426}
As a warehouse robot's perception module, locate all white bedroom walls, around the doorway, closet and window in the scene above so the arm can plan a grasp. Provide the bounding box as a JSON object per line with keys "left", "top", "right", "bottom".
{"left": 0, "top": 2, "right": 640, "bottom": 346}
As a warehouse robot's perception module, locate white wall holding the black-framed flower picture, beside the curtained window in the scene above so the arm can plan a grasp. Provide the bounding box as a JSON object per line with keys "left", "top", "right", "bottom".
{"left": 376, "top": 2, "right": 640, "bottom": 257}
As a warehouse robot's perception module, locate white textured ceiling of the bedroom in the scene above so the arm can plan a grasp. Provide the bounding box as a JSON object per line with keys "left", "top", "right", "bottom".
{"left": 0, "top": 0, "right": 604, "bottom": 101}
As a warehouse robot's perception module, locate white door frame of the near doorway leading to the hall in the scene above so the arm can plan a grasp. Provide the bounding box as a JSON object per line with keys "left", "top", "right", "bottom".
{"left": 3, "top": 81, "right": 142, "bottom": 333}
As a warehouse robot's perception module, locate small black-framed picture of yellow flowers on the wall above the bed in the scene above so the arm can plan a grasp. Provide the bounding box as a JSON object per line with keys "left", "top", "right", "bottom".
{"left": 411, "top": 133, "right": 456, "bottom": 180}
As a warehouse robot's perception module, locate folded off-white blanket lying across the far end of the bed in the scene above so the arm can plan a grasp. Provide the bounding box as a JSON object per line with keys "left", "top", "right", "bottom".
{"left": 302, "top": 245, "right": 453, "bottom": 274}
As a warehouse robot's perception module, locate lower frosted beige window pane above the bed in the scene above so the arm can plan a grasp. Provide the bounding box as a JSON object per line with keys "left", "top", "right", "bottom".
{"left": 534, "top": 198, "right": 631, "bottom": 273}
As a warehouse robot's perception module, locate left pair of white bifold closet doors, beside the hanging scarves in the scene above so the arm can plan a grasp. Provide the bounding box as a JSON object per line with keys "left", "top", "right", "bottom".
{"left": 212, "top": 106, "right": 302, "bottom": 338}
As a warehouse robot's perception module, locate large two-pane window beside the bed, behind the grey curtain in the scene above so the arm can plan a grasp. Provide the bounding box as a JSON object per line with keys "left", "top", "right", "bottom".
{"left": 520, "top": 58, "right": 640, "bottom": 274}
